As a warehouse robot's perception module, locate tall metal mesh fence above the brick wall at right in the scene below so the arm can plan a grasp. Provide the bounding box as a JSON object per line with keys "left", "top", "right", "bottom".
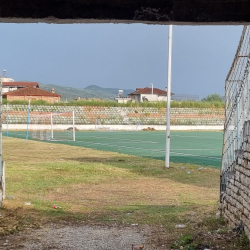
{"left": 221, "top": 26, "right": 250, "bottom": 191}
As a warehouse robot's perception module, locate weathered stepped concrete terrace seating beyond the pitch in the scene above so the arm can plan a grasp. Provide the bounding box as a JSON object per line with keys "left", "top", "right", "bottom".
{"left": 2, "top": 104, "right": 224, "bottom": 125}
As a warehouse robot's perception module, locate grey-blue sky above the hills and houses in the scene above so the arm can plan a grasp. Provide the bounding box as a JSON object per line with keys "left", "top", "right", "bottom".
{"left": 0, "top": 23, "right": 243, "bottom": 98}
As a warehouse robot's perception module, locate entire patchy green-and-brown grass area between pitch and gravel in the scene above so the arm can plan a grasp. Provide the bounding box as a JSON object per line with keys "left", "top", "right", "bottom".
{"left": 3, "top": 138, "right": 244, "bottom": 249}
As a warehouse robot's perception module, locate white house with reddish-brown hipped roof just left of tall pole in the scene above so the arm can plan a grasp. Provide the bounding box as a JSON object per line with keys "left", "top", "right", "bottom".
{"left": 128, "top": 87, "right": 173, "bottom": 102}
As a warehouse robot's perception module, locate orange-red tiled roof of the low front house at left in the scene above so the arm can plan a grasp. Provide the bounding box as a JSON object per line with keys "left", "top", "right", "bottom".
{"left": 3, "top": 86, "right": 61, "bottom": 97}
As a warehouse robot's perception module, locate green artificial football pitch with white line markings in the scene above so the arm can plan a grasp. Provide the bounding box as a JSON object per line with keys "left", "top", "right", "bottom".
{"left": 3, "top": 131, "right": 223, "bottom": 168}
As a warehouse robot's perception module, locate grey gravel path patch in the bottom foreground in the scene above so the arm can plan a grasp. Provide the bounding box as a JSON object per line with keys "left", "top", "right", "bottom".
{"left": 0, "top": 224, "right": 152, "bottom": 250}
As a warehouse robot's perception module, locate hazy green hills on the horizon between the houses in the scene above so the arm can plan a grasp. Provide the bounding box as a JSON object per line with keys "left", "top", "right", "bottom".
{"left": 39, "top": 83, "right": 134, "bottom": 101}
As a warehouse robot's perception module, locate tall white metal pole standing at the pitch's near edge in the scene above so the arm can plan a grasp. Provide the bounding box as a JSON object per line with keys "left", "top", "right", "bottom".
{"left": 165, "top": 25, "right": 173, "bottom": 168}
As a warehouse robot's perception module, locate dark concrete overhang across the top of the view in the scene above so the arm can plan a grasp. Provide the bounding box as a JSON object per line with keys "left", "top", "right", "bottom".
{"left": 0, "top": 0, "right": 250, "bottom": 24}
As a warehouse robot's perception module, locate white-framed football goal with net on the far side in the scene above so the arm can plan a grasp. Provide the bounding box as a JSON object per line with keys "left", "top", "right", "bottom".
{"left": 28, "top": 112, "right": 75, "bottom": 141}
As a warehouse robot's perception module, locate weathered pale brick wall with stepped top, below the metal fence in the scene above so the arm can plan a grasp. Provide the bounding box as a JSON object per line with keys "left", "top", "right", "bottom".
{"left": 220, "top": 121, "right": 250, "bottom": 239}
